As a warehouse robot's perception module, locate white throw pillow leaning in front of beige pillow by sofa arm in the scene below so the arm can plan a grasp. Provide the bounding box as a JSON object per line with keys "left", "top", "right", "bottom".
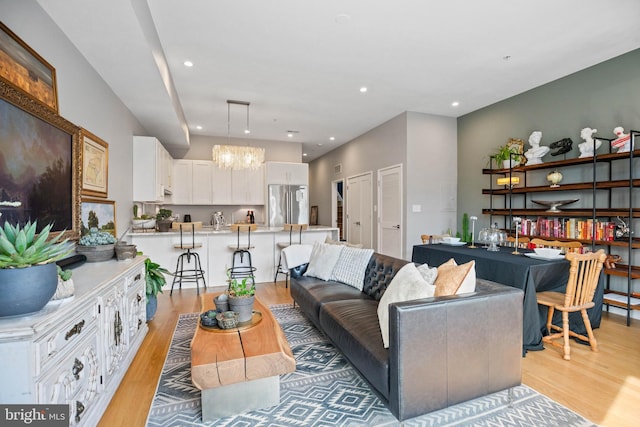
{"left": 378, "top": 262, "right": 435, "bottom": 348}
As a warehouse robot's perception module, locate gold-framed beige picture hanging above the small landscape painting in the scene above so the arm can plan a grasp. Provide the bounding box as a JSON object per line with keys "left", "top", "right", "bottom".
{"left": 80, "top": 129, "right": 109, "bottom": 198}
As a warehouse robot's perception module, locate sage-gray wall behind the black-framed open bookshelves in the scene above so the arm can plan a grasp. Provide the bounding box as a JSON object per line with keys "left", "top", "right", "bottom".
{"left": 458, "top": 50, "right": 640, "bottom": 310}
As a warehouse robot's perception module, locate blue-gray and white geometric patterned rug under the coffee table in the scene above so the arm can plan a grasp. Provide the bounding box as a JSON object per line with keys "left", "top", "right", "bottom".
{"left": 147, "top": 305, "right": 594, "bottom": 427}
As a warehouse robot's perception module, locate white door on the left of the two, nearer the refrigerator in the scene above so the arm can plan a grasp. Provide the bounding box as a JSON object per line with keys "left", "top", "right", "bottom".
{"left": 346, "top": 172, "right": 373, "bottom": 248}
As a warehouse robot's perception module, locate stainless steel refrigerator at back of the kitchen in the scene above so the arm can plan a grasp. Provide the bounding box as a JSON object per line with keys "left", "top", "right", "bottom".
{"left": 267, "top": 184, "right": 309, "bottom": 227}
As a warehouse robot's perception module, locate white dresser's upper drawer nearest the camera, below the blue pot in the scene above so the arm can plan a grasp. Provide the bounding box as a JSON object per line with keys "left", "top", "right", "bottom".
{"left": 34, "top": 302, "right": 98, "bottom": 375}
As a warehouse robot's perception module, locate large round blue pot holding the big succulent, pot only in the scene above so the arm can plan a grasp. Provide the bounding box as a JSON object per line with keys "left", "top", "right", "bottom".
{"left": 0, "top": 263, "right": 58, "bottom": 317}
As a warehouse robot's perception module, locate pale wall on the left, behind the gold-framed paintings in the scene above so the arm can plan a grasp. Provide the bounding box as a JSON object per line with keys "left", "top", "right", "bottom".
{"left": 0, "top": 1, "right": 146, "bottom": 234}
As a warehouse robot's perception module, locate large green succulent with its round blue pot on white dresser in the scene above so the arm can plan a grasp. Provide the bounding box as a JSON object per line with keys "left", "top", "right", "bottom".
{"left": 0, "top": 221, "right": 74, "bottom": 317}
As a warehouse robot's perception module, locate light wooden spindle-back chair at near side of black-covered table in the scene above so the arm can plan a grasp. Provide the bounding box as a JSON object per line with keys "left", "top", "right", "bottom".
{"left": 536, "top": 249, "right": 607, "bottom": 360}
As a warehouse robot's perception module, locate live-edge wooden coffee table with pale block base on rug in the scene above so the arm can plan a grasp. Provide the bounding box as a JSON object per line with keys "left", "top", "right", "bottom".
{"left": 191, "top": 293, "right": 296, "bottom": 421}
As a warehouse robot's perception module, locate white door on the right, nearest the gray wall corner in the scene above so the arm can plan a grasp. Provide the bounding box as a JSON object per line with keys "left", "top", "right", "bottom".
{"left": 378, "top": 165, "right": 404, "bottom": 259}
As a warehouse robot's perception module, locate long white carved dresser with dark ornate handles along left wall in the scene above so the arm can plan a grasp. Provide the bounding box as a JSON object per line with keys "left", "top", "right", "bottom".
{"left": 0, "top": 256, "right": 148, "bottom": 426}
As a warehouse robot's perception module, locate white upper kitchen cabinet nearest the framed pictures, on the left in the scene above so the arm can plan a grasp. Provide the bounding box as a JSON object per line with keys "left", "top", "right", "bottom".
{"left": 133, "top": 136, "right": 173, "bottom": 203}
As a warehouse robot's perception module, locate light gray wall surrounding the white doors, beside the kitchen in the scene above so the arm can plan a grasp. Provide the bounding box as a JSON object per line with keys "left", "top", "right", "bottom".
{"left": 309, "top": 112, "right": 457, "bottom": 259}
